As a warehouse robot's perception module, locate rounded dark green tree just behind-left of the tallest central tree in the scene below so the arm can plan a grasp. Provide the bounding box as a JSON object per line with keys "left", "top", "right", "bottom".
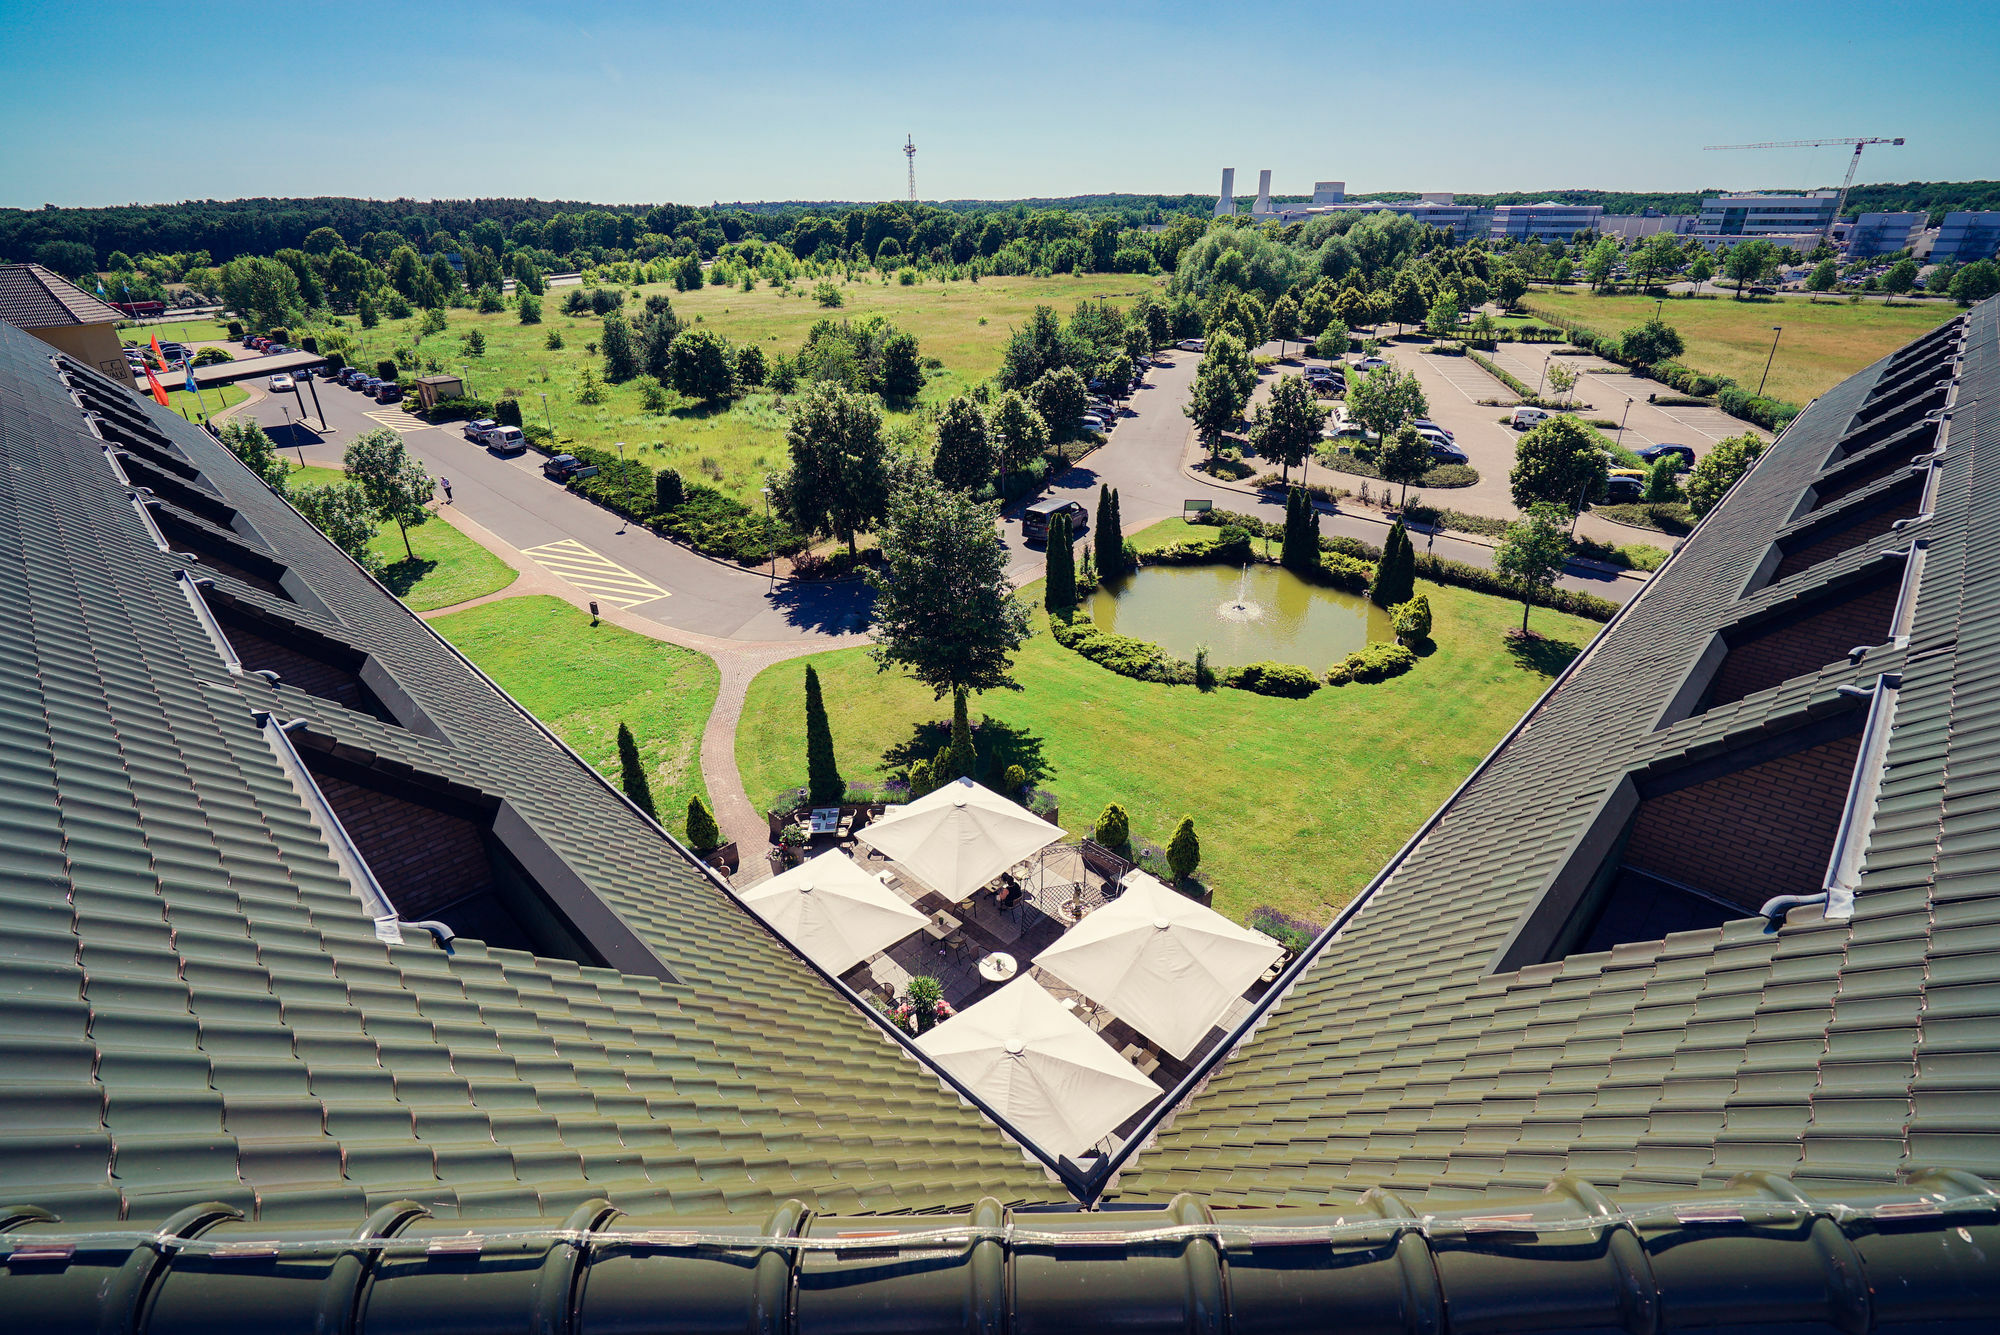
{"left": 768, "top": 379, "right": 888, "bottom": 554}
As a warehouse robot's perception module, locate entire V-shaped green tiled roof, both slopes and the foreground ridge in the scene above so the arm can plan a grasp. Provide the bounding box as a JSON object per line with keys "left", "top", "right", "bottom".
{"left": 0, "top": 302, "right": 2000, "bottom": 1331}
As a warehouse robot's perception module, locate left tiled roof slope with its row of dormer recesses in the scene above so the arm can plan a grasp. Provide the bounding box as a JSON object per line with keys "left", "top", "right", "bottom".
{"left": 0, "top": 315, "right": 1066, "bottom": 1223}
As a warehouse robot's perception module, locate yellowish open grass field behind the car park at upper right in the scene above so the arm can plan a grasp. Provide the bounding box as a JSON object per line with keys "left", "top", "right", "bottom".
{"left": 1522, "top": 292, "right": 1958, "bottom": 404}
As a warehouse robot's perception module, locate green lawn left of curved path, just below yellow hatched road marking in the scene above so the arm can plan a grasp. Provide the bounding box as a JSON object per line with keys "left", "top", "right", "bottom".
{"left": 426, "top": 595, "right": 720, "bottom": 831}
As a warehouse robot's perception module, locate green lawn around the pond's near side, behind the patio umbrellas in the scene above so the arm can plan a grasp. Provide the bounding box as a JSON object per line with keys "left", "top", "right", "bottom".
{"left": 736, "top": 530, "right": 1598, "bottom": 923}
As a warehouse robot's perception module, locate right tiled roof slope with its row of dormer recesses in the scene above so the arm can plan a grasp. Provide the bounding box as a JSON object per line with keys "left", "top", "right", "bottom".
{"left": 1122, "top": 302, "right": 2000, "bottom": 1205}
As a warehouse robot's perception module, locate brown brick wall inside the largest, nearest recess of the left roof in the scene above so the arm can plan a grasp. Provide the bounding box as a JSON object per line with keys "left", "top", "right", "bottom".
{"left": 308, "top": 757, "right": 492, "bottom": 919}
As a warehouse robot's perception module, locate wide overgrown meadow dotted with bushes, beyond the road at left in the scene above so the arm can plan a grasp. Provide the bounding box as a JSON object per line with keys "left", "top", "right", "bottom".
{"left": 312, "top": 274, "right": 1156, "bottom": 504}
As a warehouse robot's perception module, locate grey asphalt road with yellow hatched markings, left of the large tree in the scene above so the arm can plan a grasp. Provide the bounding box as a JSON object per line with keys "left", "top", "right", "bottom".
{"left": 244, "top": 382, "right": 868, "bottom": 642}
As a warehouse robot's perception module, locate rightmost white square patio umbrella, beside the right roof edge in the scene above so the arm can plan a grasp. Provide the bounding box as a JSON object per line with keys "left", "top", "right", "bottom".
{"left": 1034, "top": 871, "right": 1284, "bottom": 1057}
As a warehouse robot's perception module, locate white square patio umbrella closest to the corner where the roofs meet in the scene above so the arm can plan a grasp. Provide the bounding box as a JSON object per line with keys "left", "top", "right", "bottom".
{"left": 916, "top": 975, "right": 1160, "bottom": 1159}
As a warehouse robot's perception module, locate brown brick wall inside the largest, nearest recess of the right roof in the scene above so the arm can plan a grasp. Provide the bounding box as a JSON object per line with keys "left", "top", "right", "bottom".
{"left": 1624, "top": 733, "right": 1860, "bottom": 913}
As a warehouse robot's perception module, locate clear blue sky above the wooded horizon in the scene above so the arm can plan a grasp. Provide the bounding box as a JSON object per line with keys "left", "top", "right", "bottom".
{"left": 0, "top": 0, "right": 2000, "bottom": 208}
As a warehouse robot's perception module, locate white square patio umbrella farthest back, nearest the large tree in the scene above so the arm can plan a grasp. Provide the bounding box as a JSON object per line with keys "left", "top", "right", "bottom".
{"left": 854, "top": 779, "right": 1062, "bottom": 901}
